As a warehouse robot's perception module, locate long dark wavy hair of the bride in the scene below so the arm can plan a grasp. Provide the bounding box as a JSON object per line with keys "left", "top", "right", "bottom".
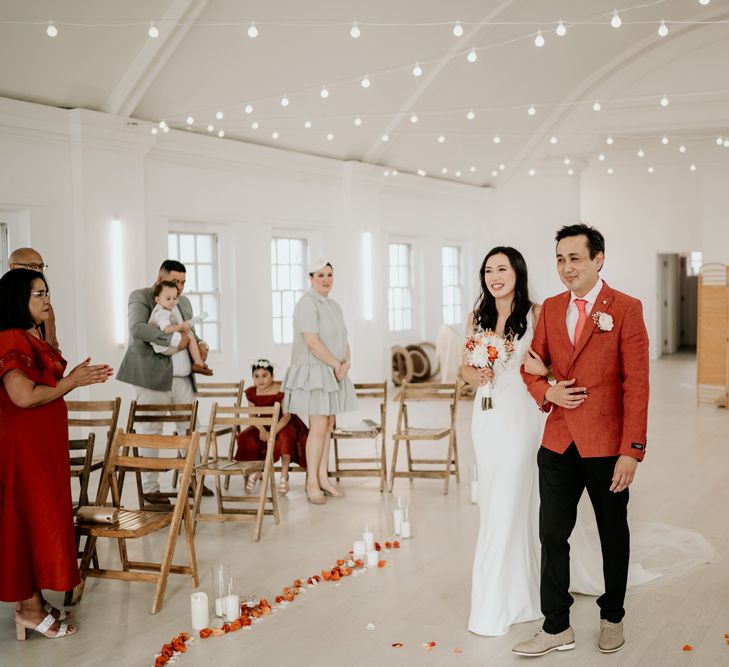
{"left": 473, "top": 246, "right": 532, "bottom": 338}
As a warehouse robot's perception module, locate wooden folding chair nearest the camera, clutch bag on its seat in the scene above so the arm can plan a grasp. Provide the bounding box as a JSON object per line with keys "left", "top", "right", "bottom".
{"left": 74, "top": 429, "right": 200, "bottom": 614}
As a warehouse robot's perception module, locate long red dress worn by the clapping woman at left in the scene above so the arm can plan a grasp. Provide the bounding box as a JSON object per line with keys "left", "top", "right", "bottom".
{"left": 0, "top": 329, "right": 79, "bottom": 602}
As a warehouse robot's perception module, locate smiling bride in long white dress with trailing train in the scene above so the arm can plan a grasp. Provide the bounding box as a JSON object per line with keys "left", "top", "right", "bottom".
{"left": 463, "top": 247, "right": 718, "bottom": 636}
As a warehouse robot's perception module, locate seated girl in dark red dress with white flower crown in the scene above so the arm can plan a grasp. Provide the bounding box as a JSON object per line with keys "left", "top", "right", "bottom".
{"left": 235, "top": 359, "right": 309, "bottom": 496}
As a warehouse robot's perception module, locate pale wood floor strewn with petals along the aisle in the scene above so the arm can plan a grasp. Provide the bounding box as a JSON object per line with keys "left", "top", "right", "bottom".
{"left": 0, "top": 355, "right": 729, "bottom": 667}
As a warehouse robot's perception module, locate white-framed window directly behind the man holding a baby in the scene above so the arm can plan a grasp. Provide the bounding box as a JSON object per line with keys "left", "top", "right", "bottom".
{"left": 167, "top": 232, "right": 220, "bottom": 352}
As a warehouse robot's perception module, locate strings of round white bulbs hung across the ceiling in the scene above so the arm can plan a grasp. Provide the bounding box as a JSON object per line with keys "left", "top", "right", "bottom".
{"left": 7, "top": 0, "right": 729, "bottom": 178}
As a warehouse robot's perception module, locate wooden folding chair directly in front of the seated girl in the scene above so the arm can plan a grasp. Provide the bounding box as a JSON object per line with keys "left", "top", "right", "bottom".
{"left": 195, "top": 403, "right": 281, "bottom": 542}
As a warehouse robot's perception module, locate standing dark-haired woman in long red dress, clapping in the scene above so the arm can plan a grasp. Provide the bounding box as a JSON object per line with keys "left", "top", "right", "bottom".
{"left": 0, "top": 269, "right": 112, "bottom": 639}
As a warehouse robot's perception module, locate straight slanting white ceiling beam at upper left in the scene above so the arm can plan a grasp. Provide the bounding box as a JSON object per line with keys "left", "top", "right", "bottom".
{"left": 101, "top": 0, "right": 209, "bottom": 116}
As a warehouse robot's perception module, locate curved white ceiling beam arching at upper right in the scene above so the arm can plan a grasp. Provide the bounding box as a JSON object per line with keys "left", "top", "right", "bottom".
{"left": 505, "top": 9, "right": 729, "bottom": 180}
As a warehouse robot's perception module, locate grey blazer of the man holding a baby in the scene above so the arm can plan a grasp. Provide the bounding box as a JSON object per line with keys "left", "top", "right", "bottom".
{"left": 116, "top": 287, "right": 200, "bottom": 391}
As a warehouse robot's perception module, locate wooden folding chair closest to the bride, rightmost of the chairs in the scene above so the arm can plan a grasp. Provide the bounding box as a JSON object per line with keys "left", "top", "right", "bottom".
{"left": 389, "top": 382, "right": 460, "bottom": 493}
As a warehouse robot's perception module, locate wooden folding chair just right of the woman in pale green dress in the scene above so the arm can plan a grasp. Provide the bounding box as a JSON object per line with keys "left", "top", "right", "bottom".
{"left": 331, "top": 382, "right": 387, "bottom": 493}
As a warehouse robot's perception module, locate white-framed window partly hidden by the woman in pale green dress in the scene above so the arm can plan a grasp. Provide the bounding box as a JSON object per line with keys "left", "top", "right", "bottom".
{"left": 271, "top": 238, "right": 307, "bottom": 343}
